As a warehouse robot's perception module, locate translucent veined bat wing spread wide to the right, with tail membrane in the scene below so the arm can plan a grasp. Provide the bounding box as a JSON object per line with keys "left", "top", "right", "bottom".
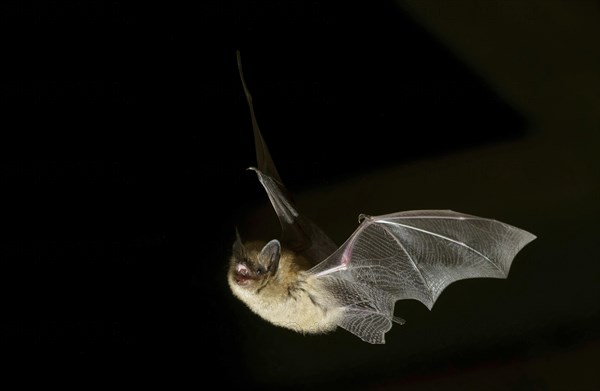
{"left": 309, "top": 210, "right": 535, "bottom": 343}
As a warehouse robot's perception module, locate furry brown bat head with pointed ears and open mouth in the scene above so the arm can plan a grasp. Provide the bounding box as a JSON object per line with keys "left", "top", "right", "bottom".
{"left": 229, "top": 235, "right": 281, "bottom": 289}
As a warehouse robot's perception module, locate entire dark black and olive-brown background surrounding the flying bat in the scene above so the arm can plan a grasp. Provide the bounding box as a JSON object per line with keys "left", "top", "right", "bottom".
{"left": 0, "top": 1, "right": 600, "bottom": 389}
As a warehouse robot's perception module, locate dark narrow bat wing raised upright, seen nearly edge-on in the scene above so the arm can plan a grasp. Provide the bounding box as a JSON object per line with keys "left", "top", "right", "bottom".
{"left": 237, "top": 51, "right": 337, "bottom": 263}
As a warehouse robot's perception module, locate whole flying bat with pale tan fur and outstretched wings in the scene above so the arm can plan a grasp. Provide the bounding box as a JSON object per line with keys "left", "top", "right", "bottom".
{"left": 227, "top": 51, "right": 536, "bottom": 344}
